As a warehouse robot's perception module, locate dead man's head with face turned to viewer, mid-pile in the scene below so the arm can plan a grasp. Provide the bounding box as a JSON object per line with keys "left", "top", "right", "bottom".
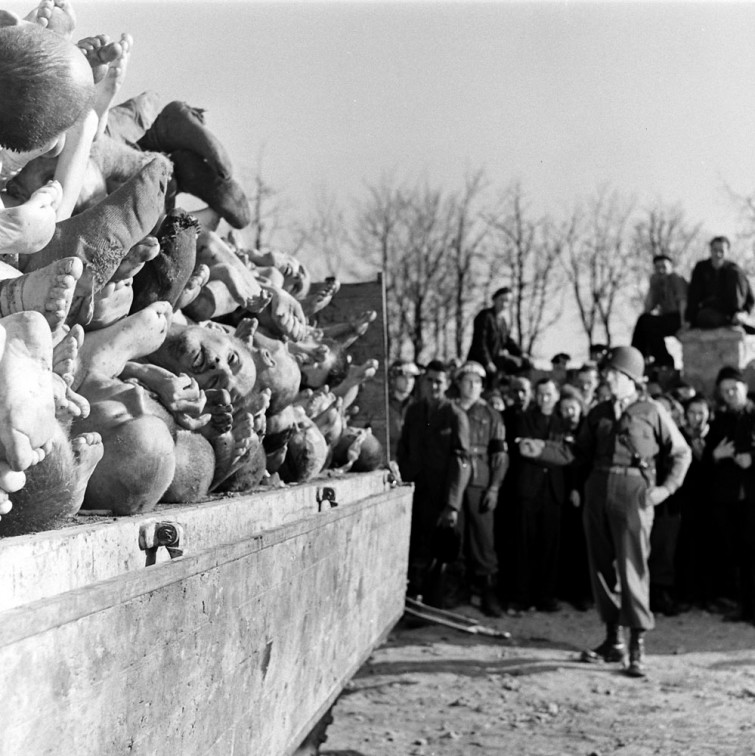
{"left": 150, "top": 325, "right": 257, "bottom": 402}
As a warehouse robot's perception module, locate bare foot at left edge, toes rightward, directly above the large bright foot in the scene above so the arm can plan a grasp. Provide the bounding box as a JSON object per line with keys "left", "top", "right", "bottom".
{"left": 0, "top": 257, "right": 84, "bottom": 331}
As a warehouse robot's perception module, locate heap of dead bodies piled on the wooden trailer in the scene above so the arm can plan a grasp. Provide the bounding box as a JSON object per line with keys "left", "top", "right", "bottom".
{"left": 0, "top": 0, "right": 383, "bottom": 535}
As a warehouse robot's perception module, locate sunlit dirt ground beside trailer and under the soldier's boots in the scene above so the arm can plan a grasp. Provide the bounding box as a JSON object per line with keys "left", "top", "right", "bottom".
{"left": 322, "top": 606, "right": 755, "bottom": 756}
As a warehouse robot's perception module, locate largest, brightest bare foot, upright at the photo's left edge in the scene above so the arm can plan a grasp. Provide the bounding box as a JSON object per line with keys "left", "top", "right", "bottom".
{"left": 0, "top": 312, "right": 56, "bottom": 471}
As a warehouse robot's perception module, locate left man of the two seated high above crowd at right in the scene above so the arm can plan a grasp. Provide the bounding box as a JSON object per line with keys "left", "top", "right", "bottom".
{"left": 632, "top": 255, "right": 687, "bottom": 367}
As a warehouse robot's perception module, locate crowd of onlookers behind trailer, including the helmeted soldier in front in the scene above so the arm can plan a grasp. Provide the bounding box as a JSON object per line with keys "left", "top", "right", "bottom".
{"left": 390, "top": 237, "right": 755, "bottom": 676}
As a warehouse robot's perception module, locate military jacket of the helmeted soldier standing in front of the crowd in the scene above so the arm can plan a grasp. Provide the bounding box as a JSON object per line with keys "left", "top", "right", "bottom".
{"left": 541, "top": 399, "right": 692, "bottom": 493}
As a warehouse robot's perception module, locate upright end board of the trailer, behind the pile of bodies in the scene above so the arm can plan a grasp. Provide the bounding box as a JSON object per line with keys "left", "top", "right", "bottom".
{"left": 318, "top": 274, "right": 389, "bottom": 455}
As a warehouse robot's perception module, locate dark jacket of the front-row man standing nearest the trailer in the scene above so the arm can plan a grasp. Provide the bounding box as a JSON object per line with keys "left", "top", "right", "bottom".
{"left": 396, "top": 399, "right": 470, "bottom": 510}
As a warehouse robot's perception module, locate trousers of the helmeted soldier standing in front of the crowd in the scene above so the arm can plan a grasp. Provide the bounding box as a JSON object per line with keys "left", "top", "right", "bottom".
{"left": 584, "top": 468, "right": 655, "bottom": 630}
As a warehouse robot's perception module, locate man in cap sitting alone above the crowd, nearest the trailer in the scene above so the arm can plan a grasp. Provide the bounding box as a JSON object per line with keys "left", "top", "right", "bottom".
{"left": 467, "top": 286, "right": 532, "bottom": 386}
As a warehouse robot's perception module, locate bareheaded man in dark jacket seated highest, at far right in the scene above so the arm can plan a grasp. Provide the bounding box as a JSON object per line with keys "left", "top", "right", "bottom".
{"left": 685, "top": 236, "right": 755, "bottom": 333}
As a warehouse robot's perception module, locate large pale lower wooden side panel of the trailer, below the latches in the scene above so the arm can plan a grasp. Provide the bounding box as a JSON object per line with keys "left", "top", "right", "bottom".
{"left": 0, "top": 488, "right": 411, "bottom": 756}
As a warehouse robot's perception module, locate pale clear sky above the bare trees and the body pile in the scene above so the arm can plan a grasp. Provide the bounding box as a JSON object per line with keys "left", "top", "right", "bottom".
{"left": 4, "top": 0, "right": 755, "bottom": 360}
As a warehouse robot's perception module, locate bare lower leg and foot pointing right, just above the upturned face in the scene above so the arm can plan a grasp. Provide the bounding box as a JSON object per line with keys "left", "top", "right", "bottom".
{"left": 74, "top": 302, "right": 173, "bottom": 385}
